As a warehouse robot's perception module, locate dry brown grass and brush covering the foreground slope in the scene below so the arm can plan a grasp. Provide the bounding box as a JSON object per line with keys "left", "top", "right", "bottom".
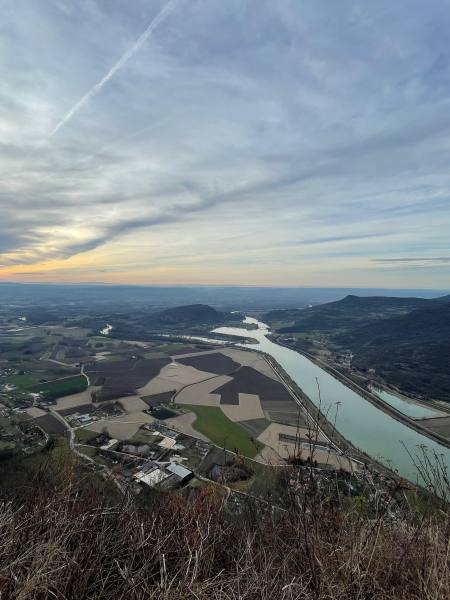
{"left": 0, "top": 450, "right": 450, "bottom": 600}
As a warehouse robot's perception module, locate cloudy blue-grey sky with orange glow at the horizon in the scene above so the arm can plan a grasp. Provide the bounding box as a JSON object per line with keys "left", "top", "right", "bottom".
{"left": 0, "top": 0, "right": 450, "bottom": 289}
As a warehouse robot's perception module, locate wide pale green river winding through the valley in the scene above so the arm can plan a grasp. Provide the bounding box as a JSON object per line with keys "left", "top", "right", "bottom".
{"left": 203, "top": 317, "right": 450, "bottom": 482}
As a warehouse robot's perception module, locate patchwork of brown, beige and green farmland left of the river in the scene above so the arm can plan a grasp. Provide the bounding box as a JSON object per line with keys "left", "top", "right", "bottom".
{"left": 0, "top": 305, "right": 356, "bottom": 476}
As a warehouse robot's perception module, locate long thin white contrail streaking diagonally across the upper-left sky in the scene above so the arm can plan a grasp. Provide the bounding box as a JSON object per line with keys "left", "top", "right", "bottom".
{"left": 29, "top": 0, "right": 179, "bottom": 156}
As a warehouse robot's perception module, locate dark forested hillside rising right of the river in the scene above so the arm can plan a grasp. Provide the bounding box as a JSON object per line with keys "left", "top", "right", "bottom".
{"left": 263, "top": 296, "right": 450, "bottom": 401}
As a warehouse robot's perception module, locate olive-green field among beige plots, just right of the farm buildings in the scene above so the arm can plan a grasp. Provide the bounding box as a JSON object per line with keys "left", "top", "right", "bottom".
{"left": 183, "top": 404, "right": 264, "bottom": 458}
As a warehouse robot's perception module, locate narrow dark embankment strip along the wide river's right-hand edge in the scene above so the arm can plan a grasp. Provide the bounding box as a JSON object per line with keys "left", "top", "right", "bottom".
{"left": 268, "top": 334, "right": 450, "bottom": 449}
